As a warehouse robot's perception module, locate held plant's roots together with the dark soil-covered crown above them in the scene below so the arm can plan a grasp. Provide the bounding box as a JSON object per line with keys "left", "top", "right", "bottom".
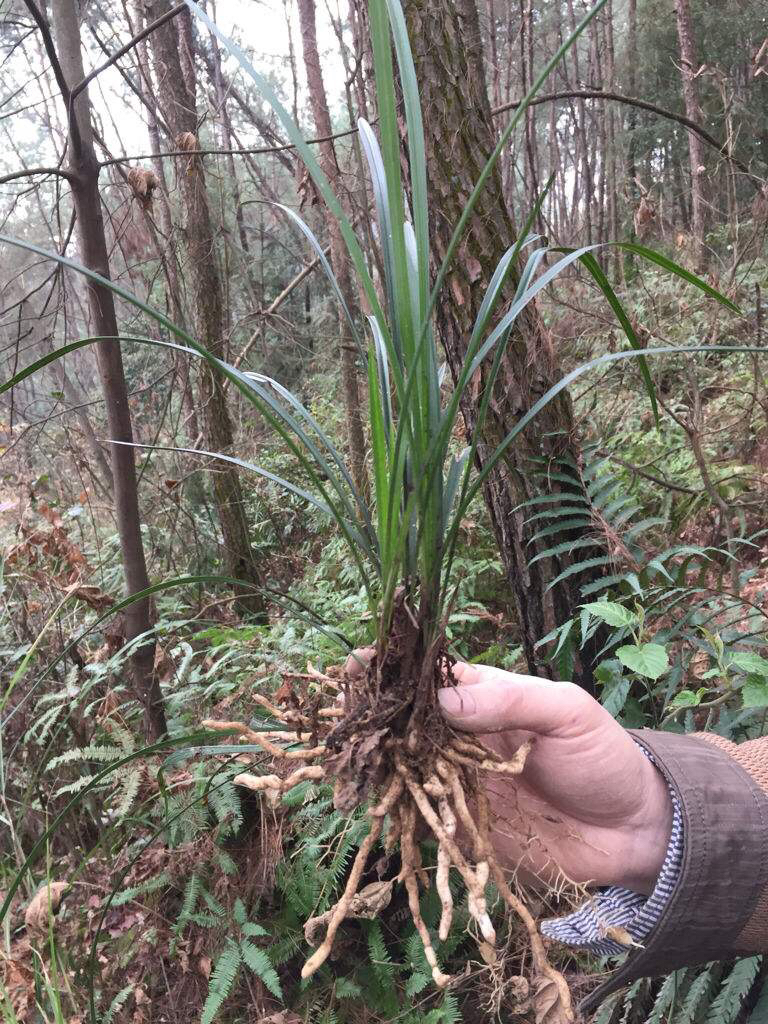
{"left": 203, "top": 595, "right": 574, "bottom": 1024}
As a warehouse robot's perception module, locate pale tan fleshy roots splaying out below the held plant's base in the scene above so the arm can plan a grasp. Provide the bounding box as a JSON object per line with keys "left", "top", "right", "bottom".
{"left": 203, "top": 671, "right": 573, "bottom": 1024}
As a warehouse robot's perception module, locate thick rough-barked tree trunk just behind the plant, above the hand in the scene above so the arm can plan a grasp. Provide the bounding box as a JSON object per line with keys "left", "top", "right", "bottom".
{"left": 404, "top": 0, "right": 606, "bottom": 690}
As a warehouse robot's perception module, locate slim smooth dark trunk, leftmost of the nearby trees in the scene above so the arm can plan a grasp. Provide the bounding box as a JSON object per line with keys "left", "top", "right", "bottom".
{"left": 52, "top": 0, "right": 167, "bottom": 741}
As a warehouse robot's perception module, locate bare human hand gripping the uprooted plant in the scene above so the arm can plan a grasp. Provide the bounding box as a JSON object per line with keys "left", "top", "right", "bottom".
{"left": 438, "top": 664, "right": 673, "bottom": 893}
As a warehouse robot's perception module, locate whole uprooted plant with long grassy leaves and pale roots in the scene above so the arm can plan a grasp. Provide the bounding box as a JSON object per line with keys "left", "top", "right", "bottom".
{"left": 0, "top": 0, "right": 735, "bottom": 1011}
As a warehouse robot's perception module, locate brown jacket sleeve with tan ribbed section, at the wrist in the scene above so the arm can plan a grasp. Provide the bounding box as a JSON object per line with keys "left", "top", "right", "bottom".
{"left": 582, "top": 729, "right": 768, "bottom": 1013}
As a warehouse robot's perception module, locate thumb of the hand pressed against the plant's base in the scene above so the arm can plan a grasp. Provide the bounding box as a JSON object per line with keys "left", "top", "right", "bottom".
{"left": 438, "top": 669, "right": 603, "bottom": 735}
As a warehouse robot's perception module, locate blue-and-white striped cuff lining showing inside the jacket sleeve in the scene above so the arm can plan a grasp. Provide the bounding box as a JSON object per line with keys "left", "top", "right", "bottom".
{"left": 541, "top": 748, "right": 684, "bottom": 956}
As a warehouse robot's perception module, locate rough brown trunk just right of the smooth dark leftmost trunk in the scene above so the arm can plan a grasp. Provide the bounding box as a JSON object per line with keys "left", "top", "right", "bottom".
{"left": 146, "top": 0, "right": 264, "bottom": 618}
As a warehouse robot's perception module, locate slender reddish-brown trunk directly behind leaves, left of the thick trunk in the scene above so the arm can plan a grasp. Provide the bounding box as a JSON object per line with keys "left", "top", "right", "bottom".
{"left": 299, "top": 0, "right": 369, "bottom": 496}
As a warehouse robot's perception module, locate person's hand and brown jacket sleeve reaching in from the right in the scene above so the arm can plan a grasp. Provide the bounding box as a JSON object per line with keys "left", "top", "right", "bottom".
{"left": 440, "top": 666, "right": 768, "bottom": 1006}
